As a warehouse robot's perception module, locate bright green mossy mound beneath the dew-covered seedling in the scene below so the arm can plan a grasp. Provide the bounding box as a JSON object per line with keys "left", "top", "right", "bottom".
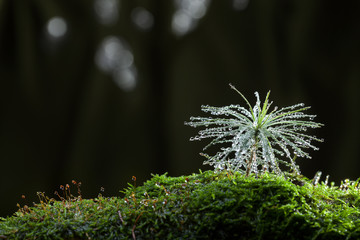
{"left": 0, "top": 171, "right": 360, "bottom": 239}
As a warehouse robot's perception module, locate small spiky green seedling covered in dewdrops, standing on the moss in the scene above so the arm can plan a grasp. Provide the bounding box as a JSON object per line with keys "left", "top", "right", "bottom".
{"left": 185, "top": 84, "right": 323, "bottom": 176}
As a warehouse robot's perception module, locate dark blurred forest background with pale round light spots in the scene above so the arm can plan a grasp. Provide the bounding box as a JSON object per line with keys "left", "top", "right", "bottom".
{"left": 0, "top": 0, "right": 360, "bottom": 216}
